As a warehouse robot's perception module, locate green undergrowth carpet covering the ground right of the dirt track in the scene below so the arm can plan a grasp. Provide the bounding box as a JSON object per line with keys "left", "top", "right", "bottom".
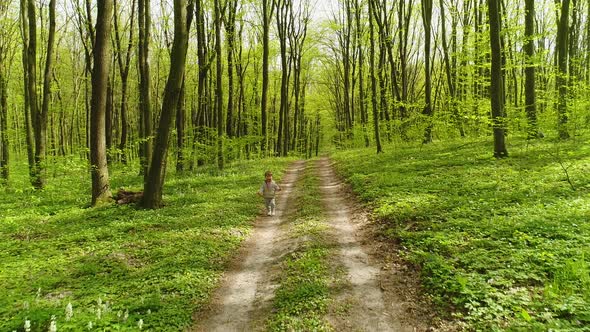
{"left": 333, "top": 138, "right": 590, "bottom": 331}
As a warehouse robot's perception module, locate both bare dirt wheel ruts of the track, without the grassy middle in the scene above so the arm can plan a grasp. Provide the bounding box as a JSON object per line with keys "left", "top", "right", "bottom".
{"left": 190, "top": 158, "right": 430, "bottom": 332}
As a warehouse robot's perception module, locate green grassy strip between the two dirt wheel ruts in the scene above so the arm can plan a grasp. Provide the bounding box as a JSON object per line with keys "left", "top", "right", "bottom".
{"left": 268, "top": 161, "right": 333, "bottom": 331}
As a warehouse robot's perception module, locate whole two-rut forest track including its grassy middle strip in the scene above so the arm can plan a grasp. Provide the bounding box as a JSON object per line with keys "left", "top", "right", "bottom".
{"left": 191, "top": 158, "right": 450, "bottom": 331}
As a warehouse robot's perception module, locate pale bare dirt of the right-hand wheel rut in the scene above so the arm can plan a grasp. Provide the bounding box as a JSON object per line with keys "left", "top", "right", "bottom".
{"left": 317, "top": 158, "right": 426, "bottom": 332}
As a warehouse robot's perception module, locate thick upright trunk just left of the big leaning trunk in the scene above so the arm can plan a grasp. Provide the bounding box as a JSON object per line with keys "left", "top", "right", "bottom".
{"left": 90, "top": 0, "right": 113, "bottom": 206}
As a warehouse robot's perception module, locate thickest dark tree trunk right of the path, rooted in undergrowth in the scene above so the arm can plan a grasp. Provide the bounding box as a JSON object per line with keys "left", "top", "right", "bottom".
{"left": 488, "top": 0, "right": 508, "bottom": 158}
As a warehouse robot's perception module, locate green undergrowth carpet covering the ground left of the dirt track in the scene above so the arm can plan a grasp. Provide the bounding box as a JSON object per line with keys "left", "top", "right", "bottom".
{"left": 0, "top": 159, "right": 289, "bottom": 331}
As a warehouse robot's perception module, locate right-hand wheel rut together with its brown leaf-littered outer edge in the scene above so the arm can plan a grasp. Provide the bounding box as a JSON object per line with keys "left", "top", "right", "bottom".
{"left": 317, "top": 158, "right": 448, "bottom": 332}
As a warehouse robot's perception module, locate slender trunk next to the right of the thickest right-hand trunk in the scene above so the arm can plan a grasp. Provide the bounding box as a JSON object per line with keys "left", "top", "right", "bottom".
{"left": 524, "top": 0, "right": 538, "bottom": 139}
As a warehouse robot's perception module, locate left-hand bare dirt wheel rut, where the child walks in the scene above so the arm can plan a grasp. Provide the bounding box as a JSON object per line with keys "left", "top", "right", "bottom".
{"left": 192, "top": 161, "right": 305, "bottom": 332}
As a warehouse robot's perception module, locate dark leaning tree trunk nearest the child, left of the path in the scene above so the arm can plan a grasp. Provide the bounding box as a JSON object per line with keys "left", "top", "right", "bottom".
{"left": 142, "top": 0, "right": 191, "bottom": 209}
